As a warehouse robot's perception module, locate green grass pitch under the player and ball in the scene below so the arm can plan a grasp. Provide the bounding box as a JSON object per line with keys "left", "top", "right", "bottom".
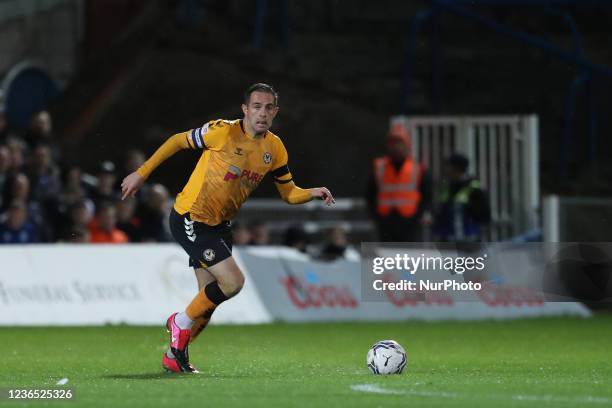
{"left": 0, "top": 316, "right": 612, "bottom": 408}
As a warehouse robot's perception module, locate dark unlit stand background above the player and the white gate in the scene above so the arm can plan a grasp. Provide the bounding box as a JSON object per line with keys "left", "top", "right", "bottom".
{"left": 3, "top": 0, "right": 612, "bottom": 197}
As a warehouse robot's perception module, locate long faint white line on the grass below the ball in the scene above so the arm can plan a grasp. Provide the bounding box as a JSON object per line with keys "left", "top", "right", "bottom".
{"left": 351, "top": 384, "right": 612, "bottom": 404}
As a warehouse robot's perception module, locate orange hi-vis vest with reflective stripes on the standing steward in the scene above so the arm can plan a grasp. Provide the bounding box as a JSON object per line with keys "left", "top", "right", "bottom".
{"left": 374, "top": 156, "right": 423, "bottom": 217}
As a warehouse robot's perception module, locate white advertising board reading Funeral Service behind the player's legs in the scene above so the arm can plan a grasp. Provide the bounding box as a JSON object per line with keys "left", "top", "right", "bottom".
{"left": 0, "top": 244, "right": 270, "bottom": 325}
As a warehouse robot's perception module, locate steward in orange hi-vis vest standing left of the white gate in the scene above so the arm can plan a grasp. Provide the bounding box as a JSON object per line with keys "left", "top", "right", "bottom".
{"left": 366, "top": 124, "right": 431, "bottom": 242}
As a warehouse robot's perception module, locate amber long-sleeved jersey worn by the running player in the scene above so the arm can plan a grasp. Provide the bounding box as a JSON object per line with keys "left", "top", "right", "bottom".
{"left": 138, "top": 119, "right": 311, "bottom": 225}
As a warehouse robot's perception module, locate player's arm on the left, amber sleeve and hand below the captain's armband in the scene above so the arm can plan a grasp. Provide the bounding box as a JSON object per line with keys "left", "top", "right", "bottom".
{"left": 121, "top": 132, "right": 191, "bottom": 200}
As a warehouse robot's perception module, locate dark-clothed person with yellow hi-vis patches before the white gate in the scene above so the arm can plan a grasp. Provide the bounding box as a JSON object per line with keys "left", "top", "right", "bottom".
{"left": 434, "top": 154, "right": 491, "bottom": 242}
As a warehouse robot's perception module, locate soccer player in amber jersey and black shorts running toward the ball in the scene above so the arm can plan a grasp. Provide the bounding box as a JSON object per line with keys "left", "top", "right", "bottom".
{"left": 121, "top": 83, "right": 335, "bottom": 372}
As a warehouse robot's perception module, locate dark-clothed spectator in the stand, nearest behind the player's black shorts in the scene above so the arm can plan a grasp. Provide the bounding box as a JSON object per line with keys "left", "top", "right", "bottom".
{"left": 137, "top": 184, "right": 172, "bottom": 242}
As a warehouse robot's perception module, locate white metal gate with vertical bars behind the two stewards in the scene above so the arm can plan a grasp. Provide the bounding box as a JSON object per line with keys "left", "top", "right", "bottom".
{"left": 391, "top": 115, "right": 540, "bottom": 241}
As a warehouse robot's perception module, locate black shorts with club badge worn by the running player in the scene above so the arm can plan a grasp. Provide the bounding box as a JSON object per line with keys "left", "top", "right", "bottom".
{"left": 170, "top": 209, "right": 232, "bottom": 268}
